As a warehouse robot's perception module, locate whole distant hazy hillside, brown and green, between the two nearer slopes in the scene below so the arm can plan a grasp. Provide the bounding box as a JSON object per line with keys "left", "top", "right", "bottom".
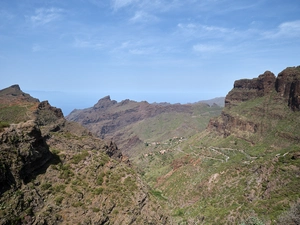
{"left": 66, "top": 96, "right": 222, "bottom": 156}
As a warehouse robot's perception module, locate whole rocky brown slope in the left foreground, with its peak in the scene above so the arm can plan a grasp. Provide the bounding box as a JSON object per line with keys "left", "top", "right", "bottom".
{"left": 0, "top": 85, "right": 169, "bottom": 225}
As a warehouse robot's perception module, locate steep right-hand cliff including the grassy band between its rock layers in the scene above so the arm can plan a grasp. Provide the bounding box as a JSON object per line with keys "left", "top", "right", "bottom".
{"left": 207, "top": 66, "right": 300, "bottom": 143}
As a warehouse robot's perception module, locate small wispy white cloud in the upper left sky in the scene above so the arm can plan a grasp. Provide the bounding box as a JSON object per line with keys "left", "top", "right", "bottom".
{"left": 30, "top": 8, "right": 64, "bottom": 25}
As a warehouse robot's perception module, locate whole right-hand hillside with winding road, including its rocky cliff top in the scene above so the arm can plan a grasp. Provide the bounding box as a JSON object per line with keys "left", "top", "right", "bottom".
{"left": 132, "top": 67, "right": 300, "bottom": 224}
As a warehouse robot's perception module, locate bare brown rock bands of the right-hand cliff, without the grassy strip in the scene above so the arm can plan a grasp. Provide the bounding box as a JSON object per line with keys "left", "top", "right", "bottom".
{"left": 207, "top": 66, "right": 300, "bottom": 137}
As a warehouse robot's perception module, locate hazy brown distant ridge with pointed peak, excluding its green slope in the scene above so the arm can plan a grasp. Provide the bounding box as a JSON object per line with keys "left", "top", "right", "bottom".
{"left": 66, "top": 96, "right": 193, "bottom": 139}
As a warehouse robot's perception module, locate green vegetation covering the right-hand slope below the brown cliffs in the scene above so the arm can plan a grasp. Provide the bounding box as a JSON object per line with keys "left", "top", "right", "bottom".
{"left": 133, "top": 93, "right": 300, "bottom": 225}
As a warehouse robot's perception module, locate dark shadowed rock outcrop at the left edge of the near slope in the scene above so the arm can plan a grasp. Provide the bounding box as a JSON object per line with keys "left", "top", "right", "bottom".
{"left": 0, "top": 121, "right": 52, "bottom": 192}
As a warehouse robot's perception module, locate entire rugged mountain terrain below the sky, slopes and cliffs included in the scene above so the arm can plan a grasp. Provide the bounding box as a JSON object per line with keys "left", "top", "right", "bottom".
{"left": 0, "top": 66, "right": 300, "bottom": 225}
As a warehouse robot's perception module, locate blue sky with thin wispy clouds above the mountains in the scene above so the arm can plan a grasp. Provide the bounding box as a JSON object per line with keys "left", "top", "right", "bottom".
{"left": 0, "top": 0, "right": 300, "bottom": 115}
